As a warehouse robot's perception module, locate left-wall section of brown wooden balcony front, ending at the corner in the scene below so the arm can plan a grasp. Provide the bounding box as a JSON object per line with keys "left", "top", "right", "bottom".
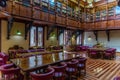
{"left": 0, "top": 1, "right": 80, "bottom": 27}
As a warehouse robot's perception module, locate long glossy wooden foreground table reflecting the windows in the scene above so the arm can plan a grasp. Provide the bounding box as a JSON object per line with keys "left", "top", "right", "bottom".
{"left": 11, "top": 52, "right": 79, "bottom": 80}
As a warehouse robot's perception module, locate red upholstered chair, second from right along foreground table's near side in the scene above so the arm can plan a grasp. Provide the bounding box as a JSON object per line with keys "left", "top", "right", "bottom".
{"left": 66, "top": 59, "right": 78, "bottom": 80}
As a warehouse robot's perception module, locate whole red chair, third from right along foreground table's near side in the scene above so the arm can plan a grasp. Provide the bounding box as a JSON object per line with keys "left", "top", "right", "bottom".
{"left": 52, "top": 62, "right": 67, "bottom": 80}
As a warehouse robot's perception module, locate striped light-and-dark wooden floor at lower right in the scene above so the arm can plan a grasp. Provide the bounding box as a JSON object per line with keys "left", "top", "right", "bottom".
{"left": 78, "top": 53, "right": 120, "bottom": 80}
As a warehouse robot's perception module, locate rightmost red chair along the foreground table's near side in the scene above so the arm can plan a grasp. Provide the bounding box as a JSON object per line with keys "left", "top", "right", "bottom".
{"left": 78, "top": 58, "right": 87, "bottom": 76}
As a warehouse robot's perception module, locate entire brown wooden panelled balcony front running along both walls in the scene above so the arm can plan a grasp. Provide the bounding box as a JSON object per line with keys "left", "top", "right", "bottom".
{"left": 3, "top": 1, "right": 120, "bottom": 30}
